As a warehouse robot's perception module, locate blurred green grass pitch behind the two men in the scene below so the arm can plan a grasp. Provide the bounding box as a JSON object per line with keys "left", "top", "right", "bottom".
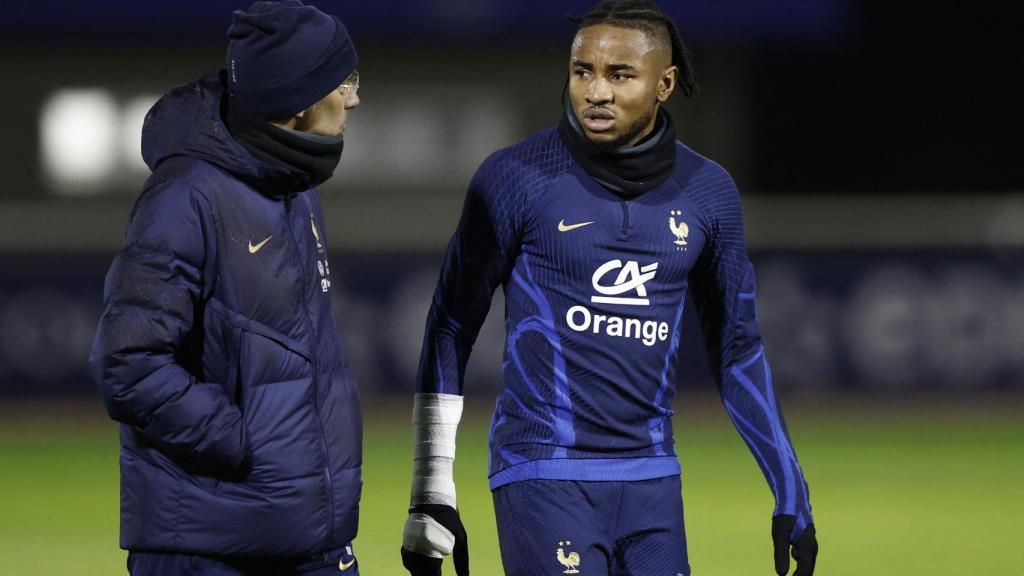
{"left": 0, "top": 398, "right": 1024, "bottom": 576}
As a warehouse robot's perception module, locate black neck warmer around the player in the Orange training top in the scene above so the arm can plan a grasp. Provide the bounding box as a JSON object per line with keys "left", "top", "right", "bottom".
{"left": 558, "top": 102, "right": 676, "bottom": 198}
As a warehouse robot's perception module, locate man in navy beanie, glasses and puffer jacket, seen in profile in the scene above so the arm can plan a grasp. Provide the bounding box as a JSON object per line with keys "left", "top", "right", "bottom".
{"left": 90, "top": 0, "right": 361, "bottom": 576}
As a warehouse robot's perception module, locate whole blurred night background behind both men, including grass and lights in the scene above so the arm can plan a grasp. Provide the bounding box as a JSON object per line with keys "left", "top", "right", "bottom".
{"left": 0, "top": 0, "right": 1024, "bottom": 576}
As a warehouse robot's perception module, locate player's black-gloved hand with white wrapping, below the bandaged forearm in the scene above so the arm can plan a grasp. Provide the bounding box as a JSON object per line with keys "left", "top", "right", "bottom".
{"left": 401, "top": 504, "right": 469, "bottom": 576}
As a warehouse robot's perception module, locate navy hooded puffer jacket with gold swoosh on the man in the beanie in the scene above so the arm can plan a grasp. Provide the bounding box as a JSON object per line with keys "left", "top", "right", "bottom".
{"left": 90, "top": 73, "right": 362, "bottom": 557}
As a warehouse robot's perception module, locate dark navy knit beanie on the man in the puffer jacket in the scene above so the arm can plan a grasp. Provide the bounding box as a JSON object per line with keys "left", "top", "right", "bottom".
{"left": 227, "top": 0, "right": 359, "bottom": 120}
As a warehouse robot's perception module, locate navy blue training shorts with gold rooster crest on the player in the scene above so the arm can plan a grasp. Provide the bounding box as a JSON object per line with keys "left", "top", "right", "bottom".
{"left": 494, "top": 476, "right": 690, "bottom": 576}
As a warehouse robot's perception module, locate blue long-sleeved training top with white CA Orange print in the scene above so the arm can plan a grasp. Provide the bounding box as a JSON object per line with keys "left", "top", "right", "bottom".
{"left": 418, "top": 128, "right": 812, "bottom": 533}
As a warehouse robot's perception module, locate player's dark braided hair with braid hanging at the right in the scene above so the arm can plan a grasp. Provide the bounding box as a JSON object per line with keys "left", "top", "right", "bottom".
{"left": 568, "top": 0, "right": 700, "bottom": 97}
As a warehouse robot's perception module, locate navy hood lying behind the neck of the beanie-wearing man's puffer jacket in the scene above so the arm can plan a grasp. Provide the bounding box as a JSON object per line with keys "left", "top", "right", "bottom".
{"left": 142, "top": 70, "right": 304, "bottom": 196}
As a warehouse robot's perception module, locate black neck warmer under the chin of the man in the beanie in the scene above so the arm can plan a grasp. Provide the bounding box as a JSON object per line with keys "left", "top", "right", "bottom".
{"left": 224, "top": 97, "right": 345, "bottom": 196}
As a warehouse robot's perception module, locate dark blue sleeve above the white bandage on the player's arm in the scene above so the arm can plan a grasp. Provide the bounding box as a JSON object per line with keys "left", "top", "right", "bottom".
{"left": 417, "top": 156, "right": 522, "bottom": 395}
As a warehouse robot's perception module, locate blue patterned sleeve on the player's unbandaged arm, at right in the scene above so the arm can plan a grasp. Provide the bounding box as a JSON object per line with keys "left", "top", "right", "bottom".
{"left": 691, "top": 171, "right": 813, "bottom": 536}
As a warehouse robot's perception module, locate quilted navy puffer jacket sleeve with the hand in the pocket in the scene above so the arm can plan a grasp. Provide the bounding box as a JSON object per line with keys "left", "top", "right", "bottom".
{"left": 90, "top": 184, "right": 246, "bottom": 470}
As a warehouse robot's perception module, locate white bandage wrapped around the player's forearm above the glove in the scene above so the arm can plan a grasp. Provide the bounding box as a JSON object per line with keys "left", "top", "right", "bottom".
{"left": 410, "top": 394, "right": 462, "bottom": 508}
